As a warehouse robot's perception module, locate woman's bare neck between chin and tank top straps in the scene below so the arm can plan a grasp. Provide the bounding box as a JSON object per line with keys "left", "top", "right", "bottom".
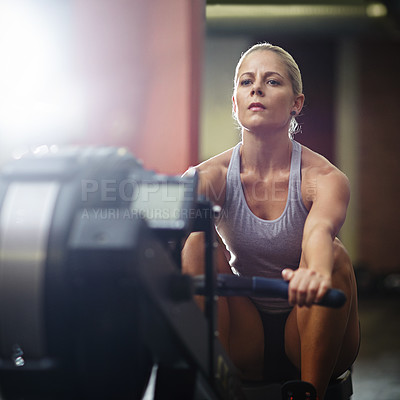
{"left": 241, "top": 132, "right": 292, "bottom": 175}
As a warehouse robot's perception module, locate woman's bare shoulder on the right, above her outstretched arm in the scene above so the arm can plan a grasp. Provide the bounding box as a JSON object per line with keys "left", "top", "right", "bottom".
{"left": 301, "top": 146, "right": 350, "bottom": 202}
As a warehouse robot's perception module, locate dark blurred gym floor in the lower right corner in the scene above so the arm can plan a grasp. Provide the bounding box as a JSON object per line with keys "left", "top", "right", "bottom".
{"left": 352, "top": 293, "right": 400, "bottom": 400}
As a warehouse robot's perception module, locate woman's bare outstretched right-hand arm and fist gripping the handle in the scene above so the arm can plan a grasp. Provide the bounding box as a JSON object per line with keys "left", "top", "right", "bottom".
{"left": 282, "top": 167, "right": 350, "bottom": 306}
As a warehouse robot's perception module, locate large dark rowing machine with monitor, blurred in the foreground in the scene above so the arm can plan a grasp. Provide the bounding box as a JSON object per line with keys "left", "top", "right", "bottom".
{"left": 0, "top": 148, "right": 354, "bottom": 400}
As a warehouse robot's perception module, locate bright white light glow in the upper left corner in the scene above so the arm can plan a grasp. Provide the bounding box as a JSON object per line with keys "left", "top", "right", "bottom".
{"left": 0, "top": 0, "right": 85, "bottom": 155}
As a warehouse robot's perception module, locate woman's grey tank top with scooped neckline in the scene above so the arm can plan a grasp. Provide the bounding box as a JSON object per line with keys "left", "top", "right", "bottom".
{"left": 216, "top": 140, "right": 308, "bottom": 313}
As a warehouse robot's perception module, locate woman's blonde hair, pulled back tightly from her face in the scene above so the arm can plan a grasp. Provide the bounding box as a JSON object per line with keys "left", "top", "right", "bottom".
{"left": 232, "top": 42, "right": 303, "bottom": 138}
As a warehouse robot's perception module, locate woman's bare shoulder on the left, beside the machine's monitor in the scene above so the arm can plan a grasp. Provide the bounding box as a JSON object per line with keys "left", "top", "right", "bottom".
{"left": 184, "top": 148, "right": 233, "bottom": 206}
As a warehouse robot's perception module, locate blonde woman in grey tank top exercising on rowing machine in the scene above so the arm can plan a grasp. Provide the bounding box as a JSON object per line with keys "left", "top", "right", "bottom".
{"left": 182, "top": 43, "right": 359, "bottom": 399}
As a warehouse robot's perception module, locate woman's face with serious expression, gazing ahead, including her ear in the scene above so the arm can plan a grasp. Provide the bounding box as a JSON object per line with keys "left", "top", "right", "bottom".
{"left": 233, "top": 50, "right": 304, "bottom": 134}
